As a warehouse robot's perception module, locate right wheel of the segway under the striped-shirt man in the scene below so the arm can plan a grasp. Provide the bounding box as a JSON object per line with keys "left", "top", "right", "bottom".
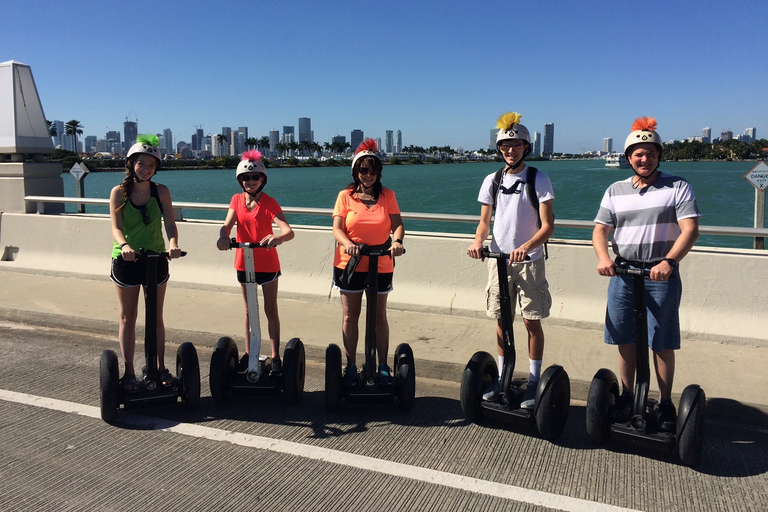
{"left": 676, "top": 384, "right": 707, "bottom": 467}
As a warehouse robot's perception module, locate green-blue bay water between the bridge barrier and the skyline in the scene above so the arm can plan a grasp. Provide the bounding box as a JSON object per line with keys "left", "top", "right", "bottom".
{"left": 63, "top": 160, "right": 756, "bottom": 248}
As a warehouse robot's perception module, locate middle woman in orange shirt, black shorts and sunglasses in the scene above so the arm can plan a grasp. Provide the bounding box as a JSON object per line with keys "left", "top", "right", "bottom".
{"left": 333, "top": 139, "right": 405, "bottom": 386}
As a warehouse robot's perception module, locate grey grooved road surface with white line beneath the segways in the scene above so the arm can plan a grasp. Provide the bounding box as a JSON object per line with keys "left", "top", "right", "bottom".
{"left": 0, "top": 322, "right": 768, "bottom": 511}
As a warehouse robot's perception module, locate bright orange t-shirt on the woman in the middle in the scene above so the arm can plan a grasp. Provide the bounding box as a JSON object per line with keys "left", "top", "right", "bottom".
{"left": 333, "top": 187, "right": 400, "bottom": 273}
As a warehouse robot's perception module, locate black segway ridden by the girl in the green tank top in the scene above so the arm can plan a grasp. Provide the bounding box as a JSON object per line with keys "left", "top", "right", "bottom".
{"left": 99, "top": 249, "right": 200, "bottom": 422}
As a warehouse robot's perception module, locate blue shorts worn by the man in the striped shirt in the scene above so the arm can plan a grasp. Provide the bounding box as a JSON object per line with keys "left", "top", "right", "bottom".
{"left": 605, "top": 269, "right": 683, "bottom": 352}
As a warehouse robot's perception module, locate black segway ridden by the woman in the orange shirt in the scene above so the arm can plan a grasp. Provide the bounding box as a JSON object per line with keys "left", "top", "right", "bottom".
{"left": 325, "top": 243, "right": 416, "bottom": 412}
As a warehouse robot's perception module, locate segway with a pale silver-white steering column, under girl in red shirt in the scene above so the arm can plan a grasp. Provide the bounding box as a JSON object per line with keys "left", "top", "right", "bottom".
{"left": 210, "top": 238, "right": 306, "bottom": 403}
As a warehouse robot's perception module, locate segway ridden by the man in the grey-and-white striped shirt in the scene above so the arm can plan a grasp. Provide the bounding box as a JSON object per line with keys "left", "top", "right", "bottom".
{"left": 587, "top": 266, "right": 707, "bottom": 466}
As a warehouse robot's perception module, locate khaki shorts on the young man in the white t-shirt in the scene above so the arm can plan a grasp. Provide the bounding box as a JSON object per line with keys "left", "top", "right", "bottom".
{"left": 485, "top": 258, "right": 552, "bottom": 320}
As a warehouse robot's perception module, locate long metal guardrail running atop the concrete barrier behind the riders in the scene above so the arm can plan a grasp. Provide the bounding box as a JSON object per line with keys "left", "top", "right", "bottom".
{"left": 19, "top": 196, "right": 768, "bottom": 238}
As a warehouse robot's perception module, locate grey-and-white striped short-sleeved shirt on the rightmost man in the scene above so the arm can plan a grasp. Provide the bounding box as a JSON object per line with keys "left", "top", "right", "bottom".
{"left": 595, "top": 172, "right": 701, "bottom": 262}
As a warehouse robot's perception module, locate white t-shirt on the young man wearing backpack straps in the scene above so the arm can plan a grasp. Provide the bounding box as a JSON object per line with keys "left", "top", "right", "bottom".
{"left": 477, "top": 165, "right": 555, "bottom": 261}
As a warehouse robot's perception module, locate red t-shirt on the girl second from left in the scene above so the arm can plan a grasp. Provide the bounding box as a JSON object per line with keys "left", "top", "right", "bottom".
{"left": 229, "top": 192, "right": 283, "bottom": 272}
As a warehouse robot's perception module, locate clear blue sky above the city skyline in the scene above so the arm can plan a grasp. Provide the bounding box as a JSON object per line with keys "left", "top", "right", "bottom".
{"left": 0, "top": 0, "right": 768, "bottom": 152}
